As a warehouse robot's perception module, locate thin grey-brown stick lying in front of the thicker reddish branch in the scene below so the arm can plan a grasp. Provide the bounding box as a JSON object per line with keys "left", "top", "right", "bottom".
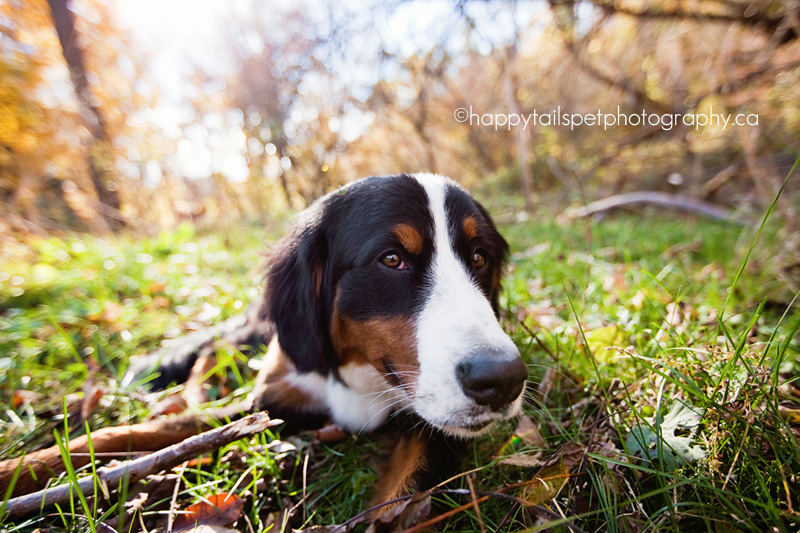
{"left": 6, "top": 412, "right": 283, "bottom": 517}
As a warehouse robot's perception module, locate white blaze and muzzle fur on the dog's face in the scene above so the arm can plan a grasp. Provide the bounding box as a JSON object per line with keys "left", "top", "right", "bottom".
{"left": 414, "top": 174, "right": 516, "bottom": 434}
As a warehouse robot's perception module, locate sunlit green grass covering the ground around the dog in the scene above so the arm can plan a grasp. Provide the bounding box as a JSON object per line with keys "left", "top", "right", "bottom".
{"left": 0, "top": 203, "right": 800, "bottom": 531}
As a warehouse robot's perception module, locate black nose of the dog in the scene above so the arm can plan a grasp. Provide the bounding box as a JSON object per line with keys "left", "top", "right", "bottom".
{"left": 456, "top": 353, "right": 528, "bottom": 411}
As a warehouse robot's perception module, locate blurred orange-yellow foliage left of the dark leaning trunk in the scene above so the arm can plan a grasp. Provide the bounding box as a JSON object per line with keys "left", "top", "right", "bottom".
{"left": 0, "top": 0, "right": 102, "bottom": 233}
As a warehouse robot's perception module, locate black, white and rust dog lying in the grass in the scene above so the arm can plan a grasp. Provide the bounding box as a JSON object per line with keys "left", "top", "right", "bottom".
{"left": 1, "top": 174, "right": 528, "bottom": 508}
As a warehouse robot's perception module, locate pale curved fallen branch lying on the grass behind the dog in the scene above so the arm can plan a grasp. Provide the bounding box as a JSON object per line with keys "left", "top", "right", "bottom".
{"left": 558, "top": 191, "right": 752, "bottom": 226}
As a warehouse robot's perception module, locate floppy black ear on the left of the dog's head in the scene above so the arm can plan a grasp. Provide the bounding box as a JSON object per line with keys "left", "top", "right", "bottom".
{"left": 265, "top": 226, "right": 335, "bottom": 372}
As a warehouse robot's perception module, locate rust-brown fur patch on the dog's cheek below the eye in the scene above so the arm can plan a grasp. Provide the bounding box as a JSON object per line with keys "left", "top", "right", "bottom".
{"left": 331, "top": 307, "right": 419, "bottom": 389}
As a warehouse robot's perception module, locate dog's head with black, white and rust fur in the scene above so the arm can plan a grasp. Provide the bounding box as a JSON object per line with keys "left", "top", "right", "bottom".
{"left": 266, "top": 174, "right": 527, "bottom": 437}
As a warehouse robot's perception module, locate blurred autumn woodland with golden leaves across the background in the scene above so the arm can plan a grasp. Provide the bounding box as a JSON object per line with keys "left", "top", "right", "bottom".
{"left": 0, "top": 0, "right": 800, "bottom": 236}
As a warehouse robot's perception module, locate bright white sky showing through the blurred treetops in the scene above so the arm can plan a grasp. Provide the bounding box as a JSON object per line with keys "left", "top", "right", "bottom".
{"left": 115, "top": 0, "right": 547, "bottom": 181}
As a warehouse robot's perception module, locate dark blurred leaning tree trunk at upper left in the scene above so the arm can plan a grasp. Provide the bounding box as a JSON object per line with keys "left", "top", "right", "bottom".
{"left": 48, "top": 0, "right": 124, "bottom": 228}
